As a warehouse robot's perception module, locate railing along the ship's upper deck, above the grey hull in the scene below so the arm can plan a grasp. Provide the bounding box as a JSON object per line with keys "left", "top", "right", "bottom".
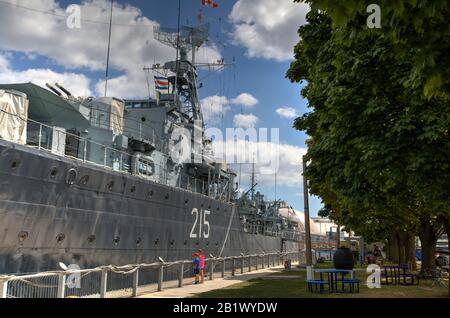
{"left": 0, "top": 109, "right": 229, "bottom": 197}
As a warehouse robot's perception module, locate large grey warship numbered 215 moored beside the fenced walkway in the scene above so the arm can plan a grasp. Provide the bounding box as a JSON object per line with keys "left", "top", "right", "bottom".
{"left": 0, "top": 25, "right": 326, "bottom": 274}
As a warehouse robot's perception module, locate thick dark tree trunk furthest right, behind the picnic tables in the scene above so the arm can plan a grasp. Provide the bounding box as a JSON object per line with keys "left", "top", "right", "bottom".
{"left": 419, "top": 219, "right": 437, "bottom": 276}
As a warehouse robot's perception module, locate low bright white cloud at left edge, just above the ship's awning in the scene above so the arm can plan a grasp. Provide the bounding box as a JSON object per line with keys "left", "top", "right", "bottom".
{"left": 0, "top": 54, "right": 92, "bottom": 96}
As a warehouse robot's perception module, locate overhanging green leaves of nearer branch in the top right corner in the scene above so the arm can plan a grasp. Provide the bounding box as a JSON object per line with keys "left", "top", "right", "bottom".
{"left": 294, "top": 0, "right": 450, "bottom": 99}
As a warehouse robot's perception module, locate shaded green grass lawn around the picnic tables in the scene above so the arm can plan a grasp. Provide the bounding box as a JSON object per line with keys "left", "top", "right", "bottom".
{"left": 195, "top": 270, "right": 448, "bottom": 298}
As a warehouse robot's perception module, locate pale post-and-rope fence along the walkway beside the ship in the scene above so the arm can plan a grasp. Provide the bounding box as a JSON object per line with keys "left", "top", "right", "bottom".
{"left": 0, "top": 251, "right": 303, "bottom": 298}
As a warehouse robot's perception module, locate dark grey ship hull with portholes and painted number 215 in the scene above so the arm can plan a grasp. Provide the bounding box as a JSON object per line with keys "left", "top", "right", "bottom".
{"left": 0, "top": 140, "right": 299, "bottom": 274}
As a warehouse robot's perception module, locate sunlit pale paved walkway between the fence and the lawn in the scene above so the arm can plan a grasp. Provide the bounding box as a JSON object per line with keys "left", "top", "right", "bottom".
{"left": 137, "top": 266, "right": 284, "bottom": 298}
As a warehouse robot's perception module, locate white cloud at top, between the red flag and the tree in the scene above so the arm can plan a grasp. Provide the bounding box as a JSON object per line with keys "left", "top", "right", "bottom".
{"left": 229, "top": 0, "right": 310, "bottom": 61}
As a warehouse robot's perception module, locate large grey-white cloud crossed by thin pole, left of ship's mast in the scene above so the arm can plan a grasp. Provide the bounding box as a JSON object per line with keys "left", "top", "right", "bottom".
{"left": 0, "top": 0, "right": 221, "bottom": 98}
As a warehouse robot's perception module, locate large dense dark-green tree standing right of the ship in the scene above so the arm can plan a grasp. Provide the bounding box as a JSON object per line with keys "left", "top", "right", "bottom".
{"left": 288, "top": 5, "right": 450, "bottom": 276}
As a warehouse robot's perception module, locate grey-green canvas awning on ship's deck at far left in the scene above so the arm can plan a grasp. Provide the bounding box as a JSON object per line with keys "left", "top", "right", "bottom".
{"left": 0, "top": 83, "right": 90, "bottom": 131}
